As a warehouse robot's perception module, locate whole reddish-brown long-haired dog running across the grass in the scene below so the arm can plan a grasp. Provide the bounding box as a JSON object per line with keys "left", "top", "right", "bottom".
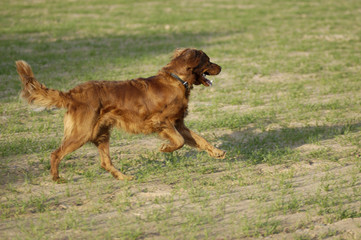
{"left": 16, "top": 48, "right": 225, "bottom": 181}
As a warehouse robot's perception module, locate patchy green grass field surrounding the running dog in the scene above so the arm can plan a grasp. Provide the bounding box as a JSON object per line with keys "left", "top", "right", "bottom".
{"left": 0, "top": 0, "right": 361, "bottom": 240}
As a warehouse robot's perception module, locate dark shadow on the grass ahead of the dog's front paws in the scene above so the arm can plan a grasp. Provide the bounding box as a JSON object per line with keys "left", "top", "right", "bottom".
{"left": 220, "top": 123, "right": 361, "bottom": 164}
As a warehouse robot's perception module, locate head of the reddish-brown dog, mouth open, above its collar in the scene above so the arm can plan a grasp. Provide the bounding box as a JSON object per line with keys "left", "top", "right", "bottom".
{"left": 168, "top": 48, "right": 221, "bottom": 87}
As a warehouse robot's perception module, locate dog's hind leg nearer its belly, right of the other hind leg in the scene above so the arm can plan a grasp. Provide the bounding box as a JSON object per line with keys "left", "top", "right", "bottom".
{"left": 92, "top": 127, "right": 133, "bottom": 180}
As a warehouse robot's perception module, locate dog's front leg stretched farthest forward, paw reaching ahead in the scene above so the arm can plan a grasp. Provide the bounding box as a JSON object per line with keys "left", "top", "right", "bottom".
{"left": 176, "top": 122, "right": 226, "bottom": 159}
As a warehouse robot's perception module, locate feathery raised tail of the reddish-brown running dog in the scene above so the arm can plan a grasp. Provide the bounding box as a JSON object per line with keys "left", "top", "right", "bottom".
{"left": 16, "top": 60, "right": 69, "bottom": 108}
